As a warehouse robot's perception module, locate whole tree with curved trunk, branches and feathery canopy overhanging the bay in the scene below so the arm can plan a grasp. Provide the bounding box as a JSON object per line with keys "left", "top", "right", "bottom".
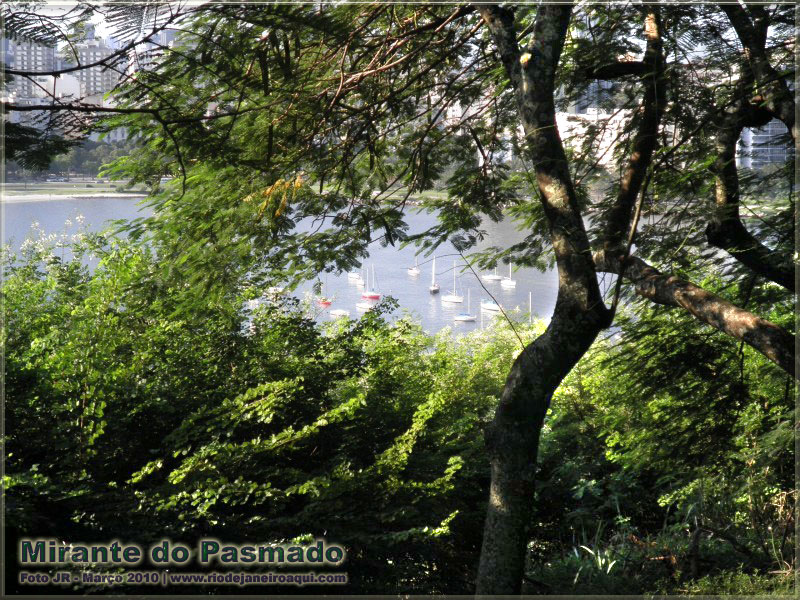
{"left": 7, "top": 3, "right": 797, "bottom": 594}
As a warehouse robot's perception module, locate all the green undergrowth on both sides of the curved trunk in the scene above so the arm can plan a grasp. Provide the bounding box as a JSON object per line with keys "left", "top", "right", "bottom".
{"left": 3, "top": 223, "right": 795, "bottom": 594}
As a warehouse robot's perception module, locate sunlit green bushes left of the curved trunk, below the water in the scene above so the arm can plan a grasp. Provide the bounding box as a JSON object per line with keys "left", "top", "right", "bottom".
{"left": 3, "top": 236, "right": 536, "bottom": 593}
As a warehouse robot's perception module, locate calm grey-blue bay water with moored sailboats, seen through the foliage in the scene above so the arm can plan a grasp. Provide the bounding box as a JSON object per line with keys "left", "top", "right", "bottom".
{"left": 2, "top": 198, "right": 558, "bottom": 332}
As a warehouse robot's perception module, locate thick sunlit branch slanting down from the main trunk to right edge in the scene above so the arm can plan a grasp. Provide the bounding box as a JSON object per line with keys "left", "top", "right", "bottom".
{"left": 595, "top": 252, "right": 797, "bottom": 377}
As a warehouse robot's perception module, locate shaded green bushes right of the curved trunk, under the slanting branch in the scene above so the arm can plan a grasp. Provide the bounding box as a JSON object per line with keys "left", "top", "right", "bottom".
{"left": 528, "top": 292, "right": 796, "bottom": 594}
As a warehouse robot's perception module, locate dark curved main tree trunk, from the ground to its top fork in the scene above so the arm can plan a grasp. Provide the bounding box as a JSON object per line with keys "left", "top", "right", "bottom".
{"left": 476, "top": 5, "right": 610, "bottom": 595}
